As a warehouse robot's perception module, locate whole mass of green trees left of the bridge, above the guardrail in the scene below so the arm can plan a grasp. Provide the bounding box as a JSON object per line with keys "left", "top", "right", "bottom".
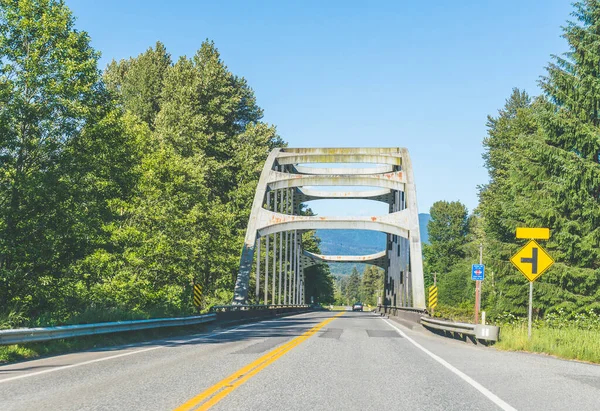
{"left": 0, "top": 0, "right": 333, "bottom": 328}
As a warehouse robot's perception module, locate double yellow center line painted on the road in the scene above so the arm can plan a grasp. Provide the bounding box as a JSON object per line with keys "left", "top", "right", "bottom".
{"left": 174, "top": 312, "right": 344, "bottom": 411}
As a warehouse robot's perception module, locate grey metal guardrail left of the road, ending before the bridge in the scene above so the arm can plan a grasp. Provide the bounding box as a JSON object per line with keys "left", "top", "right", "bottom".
{"left": 0, "top": 314, "right": 217, "bottom": 345}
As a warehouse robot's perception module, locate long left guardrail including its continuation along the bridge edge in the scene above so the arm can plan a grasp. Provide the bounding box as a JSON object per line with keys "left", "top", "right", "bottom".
{"left": 0, "top": 305, "right": 310, "bottom": 345}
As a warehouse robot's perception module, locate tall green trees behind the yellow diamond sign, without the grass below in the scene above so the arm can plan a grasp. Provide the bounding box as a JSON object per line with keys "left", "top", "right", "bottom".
{"left": 450, "top": 0, "right": 600, "bottom": 318}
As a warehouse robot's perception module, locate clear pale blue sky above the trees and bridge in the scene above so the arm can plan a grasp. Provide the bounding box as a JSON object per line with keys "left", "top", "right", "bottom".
{"left": 66, "top": 0, "right": 572, "bottom": 215}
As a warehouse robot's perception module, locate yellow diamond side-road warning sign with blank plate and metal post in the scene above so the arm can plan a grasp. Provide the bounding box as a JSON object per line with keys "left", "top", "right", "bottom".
{"left": 510, "top": 227, "right": 554, "bottom": 339}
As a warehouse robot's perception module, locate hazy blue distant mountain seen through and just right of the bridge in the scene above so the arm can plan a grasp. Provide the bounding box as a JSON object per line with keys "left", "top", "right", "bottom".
{"left": 316, "top": 213, "right": 431, "bottom": 275}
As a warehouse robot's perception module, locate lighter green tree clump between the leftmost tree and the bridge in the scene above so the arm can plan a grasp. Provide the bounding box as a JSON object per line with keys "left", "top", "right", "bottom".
{"left": 90, "top": 41, "right": 283, "bottom": 309}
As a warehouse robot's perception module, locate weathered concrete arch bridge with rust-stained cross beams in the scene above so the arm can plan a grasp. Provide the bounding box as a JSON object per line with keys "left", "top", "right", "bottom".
{"left": 233, "top": 148, "right": 425, "bottom": 308}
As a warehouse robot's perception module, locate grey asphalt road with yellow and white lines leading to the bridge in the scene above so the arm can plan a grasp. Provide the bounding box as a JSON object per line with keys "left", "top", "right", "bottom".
{"left": 0, "top": 312, "right": 600, "bottom": 411}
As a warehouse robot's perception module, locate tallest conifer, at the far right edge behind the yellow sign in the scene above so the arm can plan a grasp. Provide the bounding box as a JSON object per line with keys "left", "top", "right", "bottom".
{"left": 539, "top": 0, "right": 600, "bottom": 269}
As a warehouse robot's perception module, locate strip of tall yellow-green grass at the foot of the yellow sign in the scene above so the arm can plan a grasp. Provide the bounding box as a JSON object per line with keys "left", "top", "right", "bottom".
{"left": 495, "top": 324, "right": 600, "bottom": 363}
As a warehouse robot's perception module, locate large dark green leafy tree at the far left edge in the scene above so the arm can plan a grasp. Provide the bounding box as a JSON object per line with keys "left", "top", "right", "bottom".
{"left": 0, "top": 0, "right": 134, "bottom": 315}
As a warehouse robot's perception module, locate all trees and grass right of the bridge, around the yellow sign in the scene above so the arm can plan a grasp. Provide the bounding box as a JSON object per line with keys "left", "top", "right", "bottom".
{"left": 424, "top": 0, "right": 600, "bottom": 362}
